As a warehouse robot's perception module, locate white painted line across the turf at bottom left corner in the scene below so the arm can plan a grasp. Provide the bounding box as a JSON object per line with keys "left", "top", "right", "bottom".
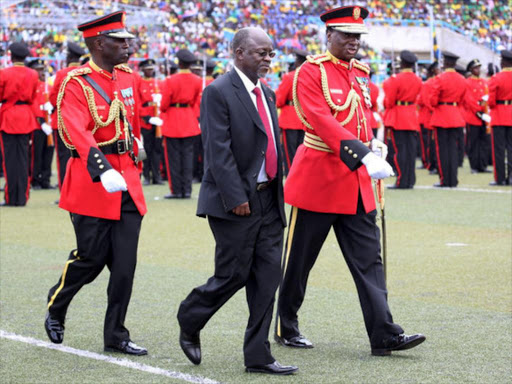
{"left": 0, "top": 329, "right": 220, "bottom": 384}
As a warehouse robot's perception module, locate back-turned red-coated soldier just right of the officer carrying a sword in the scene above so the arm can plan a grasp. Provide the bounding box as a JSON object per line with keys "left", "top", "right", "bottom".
{"left": 384, "top": 51, "right": 422, "bottom": 189}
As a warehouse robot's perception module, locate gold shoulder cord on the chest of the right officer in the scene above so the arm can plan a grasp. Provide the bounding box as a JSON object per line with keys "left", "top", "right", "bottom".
{"left": 293, "top": 58, "right": 366, "bottom": 136}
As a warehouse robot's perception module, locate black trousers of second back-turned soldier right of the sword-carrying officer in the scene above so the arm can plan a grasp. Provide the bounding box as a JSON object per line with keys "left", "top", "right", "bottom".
{"left": 435, "top": 127, "right": 460, "bottom": 187}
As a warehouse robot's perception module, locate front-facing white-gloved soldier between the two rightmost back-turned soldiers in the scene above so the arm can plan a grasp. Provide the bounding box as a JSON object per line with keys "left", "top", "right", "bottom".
{"left": 464, "top": 59, "right": 491, "bottom": 173}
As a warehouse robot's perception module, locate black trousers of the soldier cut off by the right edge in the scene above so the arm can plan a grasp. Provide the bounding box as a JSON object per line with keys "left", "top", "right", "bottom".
{"left": 492, "top": 125, "right": 512, "bottom": 184}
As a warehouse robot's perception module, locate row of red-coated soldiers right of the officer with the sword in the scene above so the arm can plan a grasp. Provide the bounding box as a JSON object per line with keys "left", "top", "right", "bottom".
{"left": 374, "top": 51, "right": 512, "bottom": 189}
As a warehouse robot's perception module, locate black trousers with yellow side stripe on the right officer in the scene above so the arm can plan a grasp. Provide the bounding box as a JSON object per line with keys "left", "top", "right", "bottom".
{"left": 276, "top": 201, "right": 403, "bottom": 346}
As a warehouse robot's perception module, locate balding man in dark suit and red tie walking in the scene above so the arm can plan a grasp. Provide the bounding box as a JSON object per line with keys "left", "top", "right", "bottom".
{"left": 178, "top": 28, "right": 297, "bottom": 375}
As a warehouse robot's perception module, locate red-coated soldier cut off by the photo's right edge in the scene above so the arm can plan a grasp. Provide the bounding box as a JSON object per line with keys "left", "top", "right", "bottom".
{"left": 489, "top": 50, "right": 512, "bottom": 185}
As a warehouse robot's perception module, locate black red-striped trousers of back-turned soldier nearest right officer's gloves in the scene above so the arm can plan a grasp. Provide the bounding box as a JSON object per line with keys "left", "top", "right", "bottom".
{"left": 391, "top": 129, "right": 417, "bottom": 188}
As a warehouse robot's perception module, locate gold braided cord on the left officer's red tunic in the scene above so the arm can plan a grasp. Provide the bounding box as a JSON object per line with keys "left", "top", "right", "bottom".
{"left": 57, "top": 68, "right": 130, "bottom": 150}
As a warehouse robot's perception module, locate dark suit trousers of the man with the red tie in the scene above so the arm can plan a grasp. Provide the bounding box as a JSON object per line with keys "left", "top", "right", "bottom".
{"left": 178, "top": 183, "right": 283, "bottom": 366}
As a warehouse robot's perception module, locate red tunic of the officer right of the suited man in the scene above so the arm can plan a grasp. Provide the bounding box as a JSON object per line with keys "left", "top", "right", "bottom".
{"left": 284, "top": 52, "right": 375, "bottom": 214}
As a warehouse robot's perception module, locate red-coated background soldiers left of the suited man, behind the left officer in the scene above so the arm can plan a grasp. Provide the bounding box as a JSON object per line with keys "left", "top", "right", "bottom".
{"left": 0, "top": 43, "right": 215, "bottom": 206}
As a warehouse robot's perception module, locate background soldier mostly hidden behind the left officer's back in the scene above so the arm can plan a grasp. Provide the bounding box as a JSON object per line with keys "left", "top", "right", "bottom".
{"left": 50, "top": 42, "right": 85, "bottom": 189}
